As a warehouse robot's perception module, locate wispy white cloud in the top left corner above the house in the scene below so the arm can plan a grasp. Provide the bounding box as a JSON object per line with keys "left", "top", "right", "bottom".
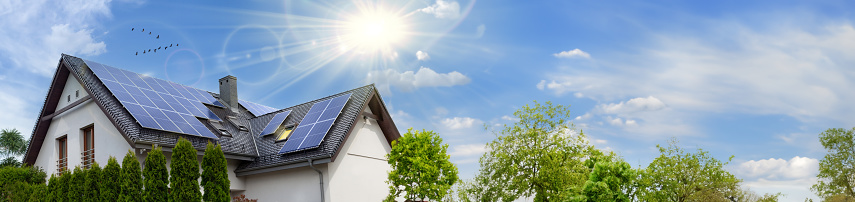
{"left": 0, "top": 0, "right": 112, "bottom": 77}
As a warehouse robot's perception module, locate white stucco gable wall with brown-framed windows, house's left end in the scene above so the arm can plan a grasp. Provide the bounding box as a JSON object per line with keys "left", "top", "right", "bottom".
{"left": 34, "top": 76, "right": 131, "bottom": 176}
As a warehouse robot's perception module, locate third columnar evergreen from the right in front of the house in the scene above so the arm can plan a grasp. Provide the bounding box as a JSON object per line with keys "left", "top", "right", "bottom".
{"left": 143, "top": 147, "right": 169, "bottom": 202}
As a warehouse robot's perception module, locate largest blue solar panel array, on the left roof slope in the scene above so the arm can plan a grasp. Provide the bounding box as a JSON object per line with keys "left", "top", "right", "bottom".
{"left": 84, "top": 60, "right": 222, "bottom": 139}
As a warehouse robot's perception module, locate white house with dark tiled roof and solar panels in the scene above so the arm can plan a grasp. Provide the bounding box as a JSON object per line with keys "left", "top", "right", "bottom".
{"left": 23, "top": 54, "right": 400, "bottom": 201}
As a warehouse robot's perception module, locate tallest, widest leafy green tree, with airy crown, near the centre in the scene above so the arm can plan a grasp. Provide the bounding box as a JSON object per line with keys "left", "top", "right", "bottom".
{"left": 472, "top": 101, "right": 593, "bottom": 201}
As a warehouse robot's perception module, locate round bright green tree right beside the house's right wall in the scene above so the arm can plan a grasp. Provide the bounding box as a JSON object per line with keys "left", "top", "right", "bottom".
{"left": 386, "top": 128, "right": 458, "bottom": 201}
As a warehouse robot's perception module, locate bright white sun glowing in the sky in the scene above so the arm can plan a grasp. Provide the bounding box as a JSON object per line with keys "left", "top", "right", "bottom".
{"left": 340, "top": 9, "right": 407, "bottom": 53}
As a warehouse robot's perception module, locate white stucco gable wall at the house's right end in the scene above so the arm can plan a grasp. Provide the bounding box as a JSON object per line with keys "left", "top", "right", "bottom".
{"left": 326, "top": 109, "right": 392, "bottom": 201}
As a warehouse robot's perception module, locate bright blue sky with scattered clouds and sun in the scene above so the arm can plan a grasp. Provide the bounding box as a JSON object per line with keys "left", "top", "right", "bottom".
{"left": 0, "top": 0, "right": 855, "bottom": 201}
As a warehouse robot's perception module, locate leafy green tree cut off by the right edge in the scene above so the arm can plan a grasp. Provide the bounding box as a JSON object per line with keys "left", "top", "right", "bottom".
{"left": 810, "top": 128, "right": 855, "bottom": 200}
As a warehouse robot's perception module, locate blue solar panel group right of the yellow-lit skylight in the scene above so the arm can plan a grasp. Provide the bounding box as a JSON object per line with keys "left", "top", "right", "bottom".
{"left": 279, "top": 93, "right": 351, "bottom": 154}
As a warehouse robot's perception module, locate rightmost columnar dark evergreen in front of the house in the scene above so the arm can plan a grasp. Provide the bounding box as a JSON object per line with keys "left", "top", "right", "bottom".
{"left": 202, "top": 142, "right": 231, "bottom": 202}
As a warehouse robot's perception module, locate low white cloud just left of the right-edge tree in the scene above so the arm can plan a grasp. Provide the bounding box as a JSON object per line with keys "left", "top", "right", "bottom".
{"left": 737, "top": 156, "right": 819, "bottom": 179}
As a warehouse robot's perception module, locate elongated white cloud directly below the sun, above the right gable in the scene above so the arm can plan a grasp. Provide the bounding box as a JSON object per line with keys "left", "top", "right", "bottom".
{"left": 366, "top": 67, "right": 471, "bottom": 92}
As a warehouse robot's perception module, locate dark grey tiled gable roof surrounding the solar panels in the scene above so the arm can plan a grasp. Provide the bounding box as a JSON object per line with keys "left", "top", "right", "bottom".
{"left": 24, "top": 54, "right": 400, "bottom": 172}
